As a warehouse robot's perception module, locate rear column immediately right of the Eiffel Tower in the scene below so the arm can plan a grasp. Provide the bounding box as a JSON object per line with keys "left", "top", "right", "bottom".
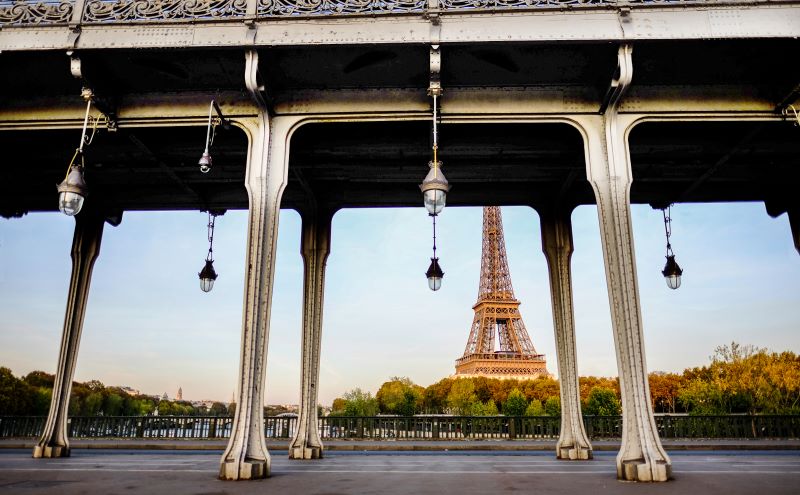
{"left": 540, "top": 208, "right": 592, "bottom": 460}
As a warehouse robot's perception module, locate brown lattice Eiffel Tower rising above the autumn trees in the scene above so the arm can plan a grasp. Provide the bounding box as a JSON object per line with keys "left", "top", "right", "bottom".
{"left": 456, "top": 206, "right": 549, "bottom": 380}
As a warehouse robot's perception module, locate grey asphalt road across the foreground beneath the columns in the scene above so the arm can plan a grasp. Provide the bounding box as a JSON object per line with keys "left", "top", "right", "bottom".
{"left": 0, "top": 449, "right": 800, "bottom": 495}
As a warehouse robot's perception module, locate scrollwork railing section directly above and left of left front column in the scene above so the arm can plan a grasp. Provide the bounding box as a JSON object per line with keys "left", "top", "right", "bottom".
{"left": 83, "top": 0, "right": 247, "bottom": 22}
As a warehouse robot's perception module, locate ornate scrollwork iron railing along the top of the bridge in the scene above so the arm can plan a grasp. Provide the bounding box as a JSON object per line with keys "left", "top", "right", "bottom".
{"left": 0, "top": 0, "right": 792, "bottom": 27}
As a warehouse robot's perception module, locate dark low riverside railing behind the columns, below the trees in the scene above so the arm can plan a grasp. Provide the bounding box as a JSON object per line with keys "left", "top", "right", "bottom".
{"left": 0, "top": 415, "right": 800, "bottom": 440}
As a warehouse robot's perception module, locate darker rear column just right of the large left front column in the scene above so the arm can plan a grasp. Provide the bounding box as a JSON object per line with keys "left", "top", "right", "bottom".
{"left": 289, "top": 207, "right": 333, "bottom": 459}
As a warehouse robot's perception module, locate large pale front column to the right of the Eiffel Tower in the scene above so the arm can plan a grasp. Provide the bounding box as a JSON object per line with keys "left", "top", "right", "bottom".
{"left": 585, "top": 110, "right": 671, "bottom": 481}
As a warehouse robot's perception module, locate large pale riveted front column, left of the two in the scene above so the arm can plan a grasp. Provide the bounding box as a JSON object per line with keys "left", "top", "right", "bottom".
{"left": 219, "top": 113, "right": 291, "bottom": 480}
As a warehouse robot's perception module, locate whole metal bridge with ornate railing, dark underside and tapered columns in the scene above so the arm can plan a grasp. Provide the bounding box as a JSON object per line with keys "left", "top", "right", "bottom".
{"left": 0, "top": 0, "right": 800, "bottom": 481}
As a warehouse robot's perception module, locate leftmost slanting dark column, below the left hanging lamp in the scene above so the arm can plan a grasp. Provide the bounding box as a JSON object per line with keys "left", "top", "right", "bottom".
{"left": 33, "top": 210, "right": 105, "bottom": 457}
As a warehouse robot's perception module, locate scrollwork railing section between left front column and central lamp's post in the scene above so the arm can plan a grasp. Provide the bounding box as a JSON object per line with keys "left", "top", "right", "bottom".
{"left": 258, "top": 0, "right": 428, "bottom": 17}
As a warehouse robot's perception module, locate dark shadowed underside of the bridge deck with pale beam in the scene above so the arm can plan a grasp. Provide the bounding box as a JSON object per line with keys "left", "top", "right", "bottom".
{"left": 0, "top": 39, "right": 800, "bottom": 216}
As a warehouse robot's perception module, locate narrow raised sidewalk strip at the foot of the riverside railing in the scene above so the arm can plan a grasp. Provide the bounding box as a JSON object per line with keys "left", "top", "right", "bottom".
{"left": 0, "top": 438, "right": 800, "bottom": 452}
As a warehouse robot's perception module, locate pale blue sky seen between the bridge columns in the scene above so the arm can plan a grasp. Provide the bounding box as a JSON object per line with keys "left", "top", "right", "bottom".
{"left": 0, "top": 201, "right": 800, "bottom": 405}
